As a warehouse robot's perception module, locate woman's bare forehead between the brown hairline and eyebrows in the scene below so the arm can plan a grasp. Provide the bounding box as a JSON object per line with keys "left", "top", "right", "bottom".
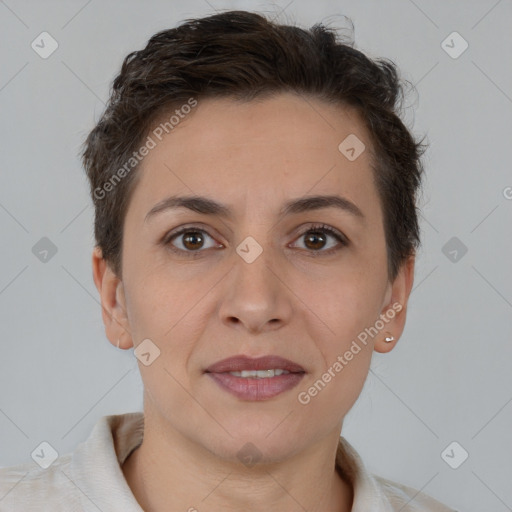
{"left": 125, "top": 93, "right": 378, "bottom": 224}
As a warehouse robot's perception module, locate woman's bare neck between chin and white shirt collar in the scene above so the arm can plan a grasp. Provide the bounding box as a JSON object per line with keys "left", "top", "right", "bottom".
{"left": 122, "top": 422, "right": 353, "bottom": 512}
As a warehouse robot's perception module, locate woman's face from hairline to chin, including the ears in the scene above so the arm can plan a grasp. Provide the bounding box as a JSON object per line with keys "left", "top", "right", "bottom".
{"left": 93, "top": 94, "right": 412, "bottom": 464}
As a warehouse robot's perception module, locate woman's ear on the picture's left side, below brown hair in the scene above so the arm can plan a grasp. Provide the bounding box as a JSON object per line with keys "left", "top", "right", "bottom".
{"left": 92, "top": 246, "right": 133, "bottom": 349}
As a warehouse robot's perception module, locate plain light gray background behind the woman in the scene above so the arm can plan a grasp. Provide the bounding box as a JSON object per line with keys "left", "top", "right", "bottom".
{"left": 0, "top": 0, "right": 512, "bottom": 512}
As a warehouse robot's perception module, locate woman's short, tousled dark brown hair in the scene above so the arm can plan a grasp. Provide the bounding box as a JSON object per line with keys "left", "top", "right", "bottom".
{"left": 82, "top": 11, "right": 425, "bottom": 280}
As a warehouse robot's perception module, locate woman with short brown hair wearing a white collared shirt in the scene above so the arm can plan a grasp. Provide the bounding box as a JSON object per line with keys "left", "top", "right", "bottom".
{"left": 0, "top": 11, "right": 451, "bottom": 512}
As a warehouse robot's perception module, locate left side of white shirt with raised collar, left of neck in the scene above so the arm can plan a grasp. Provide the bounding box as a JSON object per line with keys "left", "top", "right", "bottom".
{"left": 0, "top": 412, "right": 144, "bottom": 512}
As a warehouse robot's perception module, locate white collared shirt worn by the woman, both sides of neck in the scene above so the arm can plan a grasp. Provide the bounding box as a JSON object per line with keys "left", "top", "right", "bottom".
{"left": 0, "top": 412, "right": 456, "bottom": 512}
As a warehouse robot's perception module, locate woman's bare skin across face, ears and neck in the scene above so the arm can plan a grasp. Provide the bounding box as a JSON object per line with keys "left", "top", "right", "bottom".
{"left": 92, "top": 93, "right": 414, "bottom": 512}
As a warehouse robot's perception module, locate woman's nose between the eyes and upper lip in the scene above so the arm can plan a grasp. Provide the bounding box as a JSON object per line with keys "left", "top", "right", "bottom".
{"left": 219, "top": 241, "right": 293, "bottom": 334}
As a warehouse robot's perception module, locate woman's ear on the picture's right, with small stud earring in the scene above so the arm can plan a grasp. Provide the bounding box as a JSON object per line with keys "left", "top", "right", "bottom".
{"left": 374, "top": 255, "right": 416, "bottom": 353}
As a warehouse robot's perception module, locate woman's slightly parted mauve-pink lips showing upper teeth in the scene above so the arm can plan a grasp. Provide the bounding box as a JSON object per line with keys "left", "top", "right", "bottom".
{"left": 205, "top": 355, "right": 306, "bottom": 401}
